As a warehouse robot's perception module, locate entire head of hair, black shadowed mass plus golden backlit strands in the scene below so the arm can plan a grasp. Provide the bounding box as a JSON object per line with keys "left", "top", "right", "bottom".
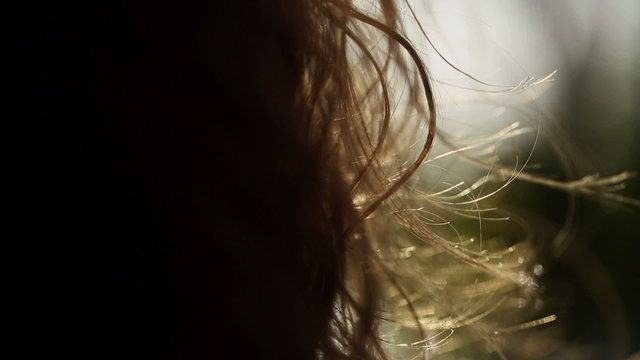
{"left": 11, "top": 0, "right": 636, "bottom": 360}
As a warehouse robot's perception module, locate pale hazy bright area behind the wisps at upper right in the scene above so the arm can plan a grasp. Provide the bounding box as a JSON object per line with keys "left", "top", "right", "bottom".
{"left": 404, "top": 0, "right": 640, "bottom": 171}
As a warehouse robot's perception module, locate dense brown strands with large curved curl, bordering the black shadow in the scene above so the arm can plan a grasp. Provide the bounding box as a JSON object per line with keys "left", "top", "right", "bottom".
{"left": 284, "top": 0, "right": 436, "bottom": 359}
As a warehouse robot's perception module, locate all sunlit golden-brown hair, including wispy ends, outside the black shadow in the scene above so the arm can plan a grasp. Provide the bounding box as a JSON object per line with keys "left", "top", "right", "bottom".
{"left": 296, "top": 0, "right": 638, "bottom": 359}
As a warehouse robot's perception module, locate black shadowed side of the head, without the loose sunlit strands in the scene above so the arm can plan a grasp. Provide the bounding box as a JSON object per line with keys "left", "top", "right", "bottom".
{"left": 14, "top": 1, "right": 410, "bottom": 359}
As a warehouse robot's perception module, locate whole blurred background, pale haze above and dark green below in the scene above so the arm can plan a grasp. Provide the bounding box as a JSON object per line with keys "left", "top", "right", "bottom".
{"left": 404, "top": 0, "right": 640, "bottom": 359}
